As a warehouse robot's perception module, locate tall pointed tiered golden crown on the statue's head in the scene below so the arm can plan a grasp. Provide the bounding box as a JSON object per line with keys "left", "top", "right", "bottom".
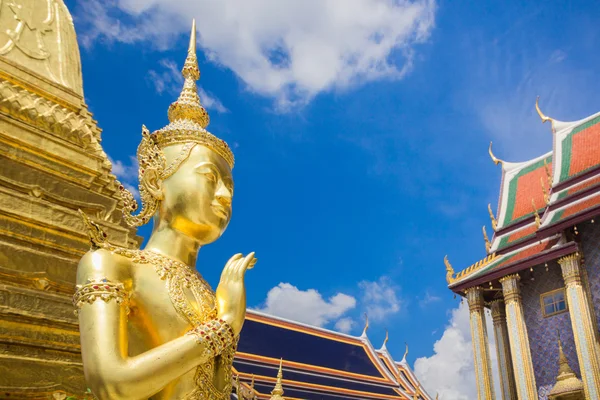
{"left": 152, "top": 20, "right": 234, "bottom": 169}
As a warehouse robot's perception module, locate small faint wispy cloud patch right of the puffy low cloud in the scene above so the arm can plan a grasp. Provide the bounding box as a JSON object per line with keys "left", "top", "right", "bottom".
{"left": 358, "top": 276, "right": 402, "bottom": 322}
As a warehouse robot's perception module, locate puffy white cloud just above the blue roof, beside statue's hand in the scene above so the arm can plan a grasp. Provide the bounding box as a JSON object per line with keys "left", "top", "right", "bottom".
{"left": 258, "top": 282, "right": 356, "bottom": 326}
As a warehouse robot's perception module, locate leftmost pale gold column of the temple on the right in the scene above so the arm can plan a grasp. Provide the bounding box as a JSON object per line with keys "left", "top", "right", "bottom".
{"left": 465, "top": 286, "right": 495, "bottom": 400}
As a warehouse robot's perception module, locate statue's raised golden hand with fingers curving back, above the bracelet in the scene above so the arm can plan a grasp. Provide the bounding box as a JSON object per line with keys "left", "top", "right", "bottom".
{"left": 217, "top": 252, "right": 256, "bottom": 335}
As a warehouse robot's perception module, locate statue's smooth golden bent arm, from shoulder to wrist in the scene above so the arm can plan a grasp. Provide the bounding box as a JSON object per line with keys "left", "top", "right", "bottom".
{"left": 75, "top": 250, "right": 230, "bottom": 400}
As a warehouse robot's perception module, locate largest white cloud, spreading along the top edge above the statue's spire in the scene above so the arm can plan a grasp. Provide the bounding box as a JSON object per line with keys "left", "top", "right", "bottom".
{"left": 77, "top": 0, "right": 436, "bottom": 107}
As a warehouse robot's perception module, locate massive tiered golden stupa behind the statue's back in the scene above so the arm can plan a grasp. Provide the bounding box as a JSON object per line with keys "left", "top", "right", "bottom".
{"left": 0, "top": 0, "right": 139, "bottom": 399}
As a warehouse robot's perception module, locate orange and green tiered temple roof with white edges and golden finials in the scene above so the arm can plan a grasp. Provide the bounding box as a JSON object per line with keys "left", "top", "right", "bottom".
{"left": 446, "top": 101, "right": 600, "bottom": 290}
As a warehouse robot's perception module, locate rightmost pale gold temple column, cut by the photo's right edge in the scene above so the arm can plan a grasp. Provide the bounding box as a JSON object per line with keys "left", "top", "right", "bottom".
{"left": 558, "top": 253, "right": 600, "bottom": 399}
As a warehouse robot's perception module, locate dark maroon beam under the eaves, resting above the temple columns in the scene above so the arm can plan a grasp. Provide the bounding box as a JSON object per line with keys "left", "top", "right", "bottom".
{"left": 451, "top": 242, "right": 579, "bottom": 293}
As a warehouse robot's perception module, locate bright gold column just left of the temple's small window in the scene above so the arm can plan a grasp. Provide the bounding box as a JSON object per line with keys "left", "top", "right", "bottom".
{"left": 500, "top": 274, "right": 538, "bottom": 400}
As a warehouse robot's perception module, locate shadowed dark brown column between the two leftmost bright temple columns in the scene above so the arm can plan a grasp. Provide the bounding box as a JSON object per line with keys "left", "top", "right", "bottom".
{"left": 491, "top": 300, "right": 517, "bottom": 400}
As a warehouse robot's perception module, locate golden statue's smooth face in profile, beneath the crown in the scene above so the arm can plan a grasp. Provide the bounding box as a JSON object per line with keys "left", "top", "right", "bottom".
{"left": 159, "top": 145, "right": 233, "bottom": 244}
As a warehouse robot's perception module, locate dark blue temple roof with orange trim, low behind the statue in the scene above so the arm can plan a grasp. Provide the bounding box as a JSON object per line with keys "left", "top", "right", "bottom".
{"left": 234, "top": 310, "right": 430, "bottom": 400}
